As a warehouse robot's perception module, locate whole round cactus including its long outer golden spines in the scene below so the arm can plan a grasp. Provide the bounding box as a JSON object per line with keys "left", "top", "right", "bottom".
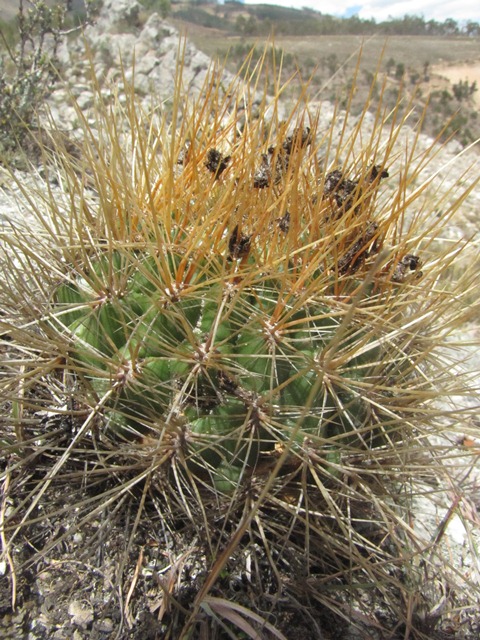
{"left": 1, "top": 52, "right": 474, "bottom": 637}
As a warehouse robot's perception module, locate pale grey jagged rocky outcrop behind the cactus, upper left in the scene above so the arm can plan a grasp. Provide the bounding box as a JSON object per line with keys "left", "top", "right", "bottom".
{"left": 49, "top": 0, "right": 216, "bottom": 130}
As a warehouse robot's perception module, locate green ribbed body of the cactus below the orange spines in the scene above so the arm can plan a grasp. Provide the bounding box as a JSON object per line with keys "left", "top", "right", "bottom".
{"left": 57, "top": 245, "right": 386, "bottom": 484}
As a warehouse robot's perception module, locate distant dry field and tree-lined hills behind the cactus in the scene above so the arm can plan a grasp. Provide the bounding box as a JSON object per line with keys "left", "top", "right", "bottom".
{"left": 163, "top": 2, "right": 480, "bottom": 145}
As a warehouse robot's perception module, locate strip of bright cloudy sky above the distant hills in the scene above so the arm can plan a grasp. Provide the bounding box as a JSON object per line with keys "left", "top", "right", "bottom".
{"left": 244, "top": 0, "right": 480, "bottom": 22}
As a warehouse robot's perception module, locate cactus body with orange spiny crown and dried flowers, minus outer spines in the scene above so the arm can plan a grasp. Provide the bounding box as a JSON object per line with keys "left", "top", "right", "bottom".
{"left": 48, "top": 117, "right": 420, "bottom": 490}
